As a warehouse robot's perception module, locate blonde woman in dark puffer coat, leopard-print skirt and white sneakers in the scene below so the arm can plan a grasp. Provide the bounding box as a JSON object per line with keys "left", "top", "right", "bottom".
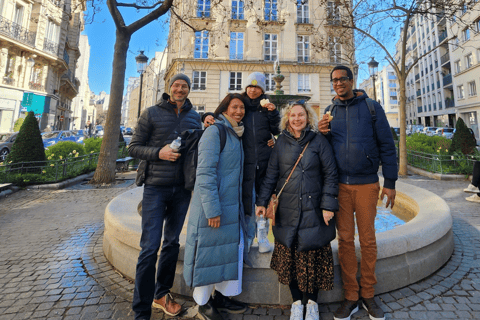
{"left": 256, "top": 103, "right": 338, "bottom": 319}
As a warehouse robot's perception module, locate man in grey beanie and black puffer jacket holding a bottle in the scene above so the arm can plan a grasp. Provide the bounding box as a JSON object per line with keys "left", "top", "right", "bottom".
{"left": 128, "top": 74, "right": 201, "bottom": 320}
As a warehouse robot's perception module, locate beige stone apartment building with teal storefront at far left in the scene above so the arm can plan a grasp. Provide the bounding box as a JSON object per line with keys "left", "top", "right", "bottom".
{"left": 0, "top": 0, "right": 85, "bottom": 131}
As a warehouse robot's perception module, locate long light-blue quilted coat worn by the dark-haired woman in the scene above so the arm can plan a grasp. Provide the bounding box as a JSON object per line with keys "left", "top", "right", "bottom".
{"left": 183, "top": 115, "right": 244, "bottom": 287}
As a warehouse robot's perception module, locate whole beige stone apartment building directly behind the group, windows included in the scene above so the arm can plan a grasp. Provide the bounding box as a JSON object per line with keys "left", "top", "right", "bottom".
{"left": 165, "top": 0, "right": 356, "bottom": 112}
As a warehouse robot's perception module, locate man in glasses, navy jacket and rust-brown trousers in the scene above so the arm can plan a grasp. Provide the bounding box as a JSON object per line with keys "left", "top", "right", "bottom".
{"left": 318, "top": 66, "right": 398, "bottom": 320}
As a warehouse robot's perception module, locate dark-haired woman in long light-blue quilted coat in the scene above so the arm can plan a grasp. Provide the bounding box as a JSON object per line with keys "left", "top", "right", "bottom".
{"left": 183, "top": 94, "right": 246, "bottom": 320}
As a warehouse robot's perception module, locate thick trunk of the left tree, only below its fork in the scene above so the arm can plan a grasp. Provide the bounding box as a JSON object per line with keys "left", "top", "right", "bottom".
{"left": 90, "top": 30, "right": 131, "bottom": 184}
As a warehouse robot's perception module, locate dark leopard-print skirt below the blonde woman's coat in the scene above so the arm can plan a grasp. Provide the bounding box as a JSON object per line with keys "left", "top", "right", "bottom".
{"left": 270, "top": 241, "right": 333, "bottom": 293}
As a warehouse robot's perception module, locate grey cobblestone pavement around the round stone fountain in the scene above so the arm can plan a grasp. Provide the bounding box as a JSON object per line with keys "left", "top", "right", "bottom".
{"left": 0, "top": 175, "right": 480, "bottom": 320}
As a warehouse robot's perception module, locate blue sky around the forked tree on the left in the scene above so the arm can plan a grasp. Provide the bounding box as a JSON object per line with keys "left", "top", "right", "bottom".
{"left": 82, "top": 2, "right": 169, "bottom": 94}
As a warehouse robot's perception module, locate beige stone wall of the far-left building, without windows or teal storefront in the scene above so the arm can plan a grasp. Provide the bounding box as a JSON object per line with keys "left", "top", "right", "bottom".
{"left": 0, "top": 0, "right": 85, "bottom": 129}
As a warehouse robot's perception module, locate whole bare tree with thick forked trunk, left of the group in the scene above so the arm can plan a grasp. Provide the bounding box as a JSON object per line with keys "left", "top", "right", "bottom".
{"left": 90, "top": 0, "right": 173, "bottom": 184}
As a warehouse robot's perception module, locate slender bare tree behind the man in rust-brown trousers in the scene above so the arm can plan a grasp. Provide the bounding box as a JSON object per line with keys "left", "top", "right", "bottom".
{"left": 316, "top": 0, "right": 477, "bottom": 175}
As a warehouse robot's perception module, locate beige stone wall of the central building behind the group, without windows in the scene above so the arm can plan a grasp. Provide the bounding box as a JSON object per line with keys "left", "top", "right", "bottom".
{"left": 165, "top": 0, "right": 353, "bottom": 116}
